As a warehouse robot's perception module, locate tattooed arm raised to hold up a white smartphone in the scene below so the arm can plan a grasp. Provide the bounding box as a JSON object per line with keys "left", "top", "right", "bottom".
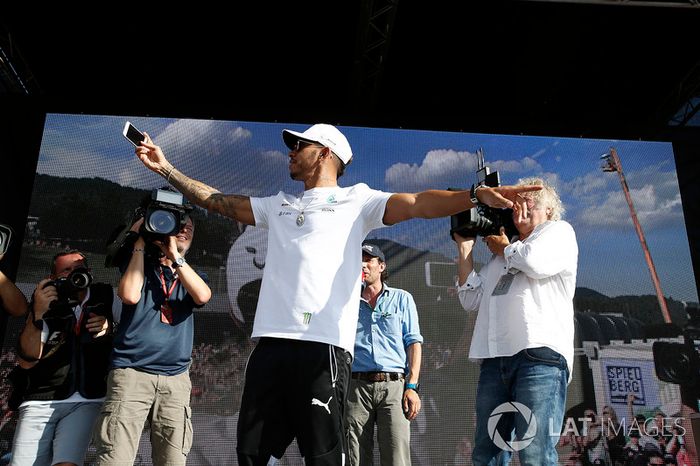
{"left": 136, "top": 133, "right": 255, "bottom": 225}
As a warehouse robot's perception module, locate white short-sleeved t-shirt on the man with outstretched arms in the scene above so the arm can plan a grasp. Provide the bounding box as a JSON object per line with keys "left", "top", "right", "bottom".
{"left": 250, "top": 184, "right": 391, "bottom": 353}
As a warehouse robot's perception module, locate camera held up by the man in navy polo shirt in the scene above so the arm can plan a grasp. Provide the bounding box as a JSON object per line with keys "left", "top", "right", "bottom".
{"left": 105, "top": 189, "right": 192, "bottom": 267}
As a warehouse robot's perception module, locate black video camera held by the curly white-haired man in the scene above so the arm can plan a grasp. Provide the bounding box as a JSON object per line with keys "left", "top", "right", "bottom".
{"left": 448, "top": 148, "right": 518, "bottom": 238}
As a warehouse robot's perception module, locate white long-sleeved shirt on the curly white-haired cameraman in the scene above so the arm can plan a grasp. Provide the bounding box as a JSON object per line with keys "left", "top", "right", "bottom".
{"left": 458, "top": 220, "right": 578, "bottom": 377}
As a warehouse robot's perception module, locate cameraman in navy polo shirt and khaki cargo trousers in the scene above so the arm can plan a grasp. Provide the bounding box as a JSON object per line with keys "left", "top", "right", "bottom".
{"left": 94, "top": 216, "right": 211, "bottom": 465}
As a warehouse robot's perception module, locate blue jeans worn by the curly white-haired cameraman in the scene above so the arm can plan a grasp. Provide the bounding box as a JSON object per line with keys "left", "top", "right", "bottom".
{"left": 472, "top": 347, "right": 569, "bottom": 466}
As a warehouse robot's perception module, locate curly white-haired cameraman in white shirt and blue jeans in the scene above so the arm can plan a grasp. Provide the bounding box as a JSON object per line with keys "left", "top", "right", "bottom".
{"left": 454, "top": 178, "right": 578, "bottom": 465}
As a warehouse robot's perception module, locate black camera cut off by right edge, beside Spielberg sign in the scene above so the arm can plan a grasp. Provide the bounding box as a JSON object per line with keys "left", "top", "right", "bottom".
{"left": 652, "top": 303, "right": 700, "bottom": 398}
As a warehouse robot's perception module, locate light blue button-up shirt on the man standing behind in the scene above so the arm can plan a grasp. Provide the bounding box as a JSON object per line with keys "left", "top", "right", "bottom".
{"left": 352, "top": 284, "right": 423, "bottom": 373}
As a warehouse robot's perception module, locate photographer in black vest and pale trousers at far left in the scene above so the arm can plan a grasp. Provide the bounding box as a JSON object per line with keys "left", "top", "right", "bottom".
{"left": 11, "top": 250, "right": 114, "bottom": 465}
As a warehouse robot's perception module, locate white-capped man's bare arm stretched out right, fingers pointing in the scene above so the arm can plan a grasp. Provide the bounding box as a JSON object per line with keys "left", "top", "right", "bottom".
{"left": 384, "top": 186, "right": 542, "bottom": 225}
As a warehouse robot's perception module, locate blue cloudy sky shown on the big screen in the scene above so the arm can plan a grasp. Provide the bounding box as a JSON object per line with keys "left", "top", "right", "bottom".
{"left": 37, "top": 114, "right": 698, "bottom": 301}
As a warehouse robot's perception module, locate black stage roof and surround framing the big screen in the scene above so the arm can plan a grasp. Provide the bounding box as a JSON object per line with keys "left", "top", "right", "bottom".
{"left": 0, "top": 0, "right": 700, "bottom": 294}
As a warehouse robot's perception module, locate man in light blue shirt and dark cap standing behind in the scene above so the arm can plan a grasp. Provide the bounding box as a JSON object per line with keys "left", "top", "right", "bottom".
{"left": 347, "top": 243, "right": 423, "bottom": 466}
